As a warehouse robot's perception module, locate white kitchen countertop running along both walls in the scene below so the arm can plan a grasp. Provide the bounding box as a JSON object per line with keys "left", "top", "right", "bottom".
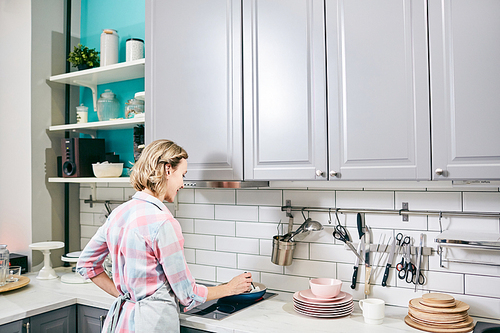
{"left": 0, "top": 268, "right": 496, "bottom": 333}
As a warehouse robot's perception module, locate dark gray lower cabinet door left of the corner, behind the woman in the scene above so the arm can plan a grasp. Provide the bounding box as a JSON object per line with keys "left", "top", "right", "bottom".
{"left": 30, "top": 305, "right": 76, "bottom": 333}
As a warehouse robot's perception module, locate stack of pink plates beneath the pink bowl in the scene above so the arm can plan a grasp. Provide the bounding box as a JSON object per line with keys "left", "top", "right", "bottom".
{"left": 293, "top": 289, "right": 354, "bottom": 318}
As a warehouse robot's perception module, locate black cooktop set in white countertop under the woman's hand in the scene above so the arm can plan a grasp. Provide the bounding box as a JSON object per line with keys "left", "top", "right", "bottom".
{"left": 184, "top": 291, "right": 277, "bottom": 320}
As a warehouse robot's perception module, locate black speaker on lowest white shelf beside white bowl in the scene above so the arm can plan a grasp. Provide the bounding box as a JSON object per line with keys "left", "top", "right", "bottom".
{"left": 61, "top": 138, "right": 106, "bottom": 178}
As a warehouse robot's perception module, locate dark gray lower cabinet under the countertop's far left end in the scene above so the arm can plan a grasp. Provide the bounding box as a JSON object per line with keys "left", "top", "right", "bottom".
{"left": 0, "top": 305, "right": 77, "bottom": 333}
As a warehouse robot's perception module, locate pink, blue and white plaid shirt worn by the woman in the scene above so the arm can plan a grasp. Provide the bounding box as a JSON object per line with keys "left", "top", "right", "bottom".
{"left": 77, "top": 192, "right": 208, "bottom": 332}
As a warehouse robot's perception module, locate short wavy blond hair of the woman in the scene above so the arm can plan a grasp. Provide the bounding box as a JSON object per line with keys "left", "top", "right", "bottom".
{"left": 130, "top": 140, "right": 188, "bottom": 197}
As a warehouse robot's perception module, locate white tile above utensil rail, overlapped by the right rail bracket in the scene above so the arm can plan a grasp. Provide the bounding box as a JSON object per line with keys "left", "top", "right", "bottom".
{"left": 396, "top": 192, "right": 462, "bottom": 211}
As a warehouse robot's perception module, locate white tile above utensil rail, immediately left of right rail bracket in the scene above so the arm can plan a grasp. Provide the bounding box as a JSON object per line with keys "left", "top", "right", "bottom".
{"left": 337, "top": 191, "right": 394, "bottom": 209}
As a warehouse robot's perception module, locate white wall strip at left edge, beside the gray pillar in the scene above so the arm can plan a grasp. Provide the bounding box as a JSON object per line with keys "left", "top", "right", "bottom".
{"left": 0, "top": 0, "right": 32, "bottom": 254}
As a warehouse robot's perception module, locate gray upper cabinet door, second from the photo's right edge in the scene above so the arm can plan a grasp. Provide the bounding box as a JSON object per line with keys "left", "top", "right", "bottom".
{"left": 326, "top": 0, "right": 430, "bottom": 180}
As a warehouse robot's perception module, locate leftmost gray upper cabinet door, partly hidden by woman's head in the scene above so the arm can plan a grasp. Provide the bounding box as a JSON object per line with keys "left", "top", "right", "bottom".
{"left": 146, "top": 0, "right": 243, "bottom": 180}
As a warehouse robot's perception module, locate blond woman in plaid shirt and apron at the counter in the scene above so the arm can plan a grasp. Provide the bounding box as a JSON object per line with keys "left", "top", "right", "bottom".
{"left": 77, "top": 140, "right": 252, "bottom": 332}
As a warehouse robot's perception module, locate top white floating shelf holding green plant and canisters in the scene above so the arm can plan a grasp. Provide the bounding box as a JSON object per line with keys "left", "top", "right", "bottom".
{"left": 49, "top": 59, "right": 146, "bottom": 87}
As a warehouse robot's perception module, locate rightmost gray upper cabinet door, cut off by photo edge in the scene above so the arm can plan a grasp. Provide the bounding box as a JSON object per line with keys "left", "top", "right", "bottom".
{"left": 429, "top": 0, "right": 500, "bottom": 179}
